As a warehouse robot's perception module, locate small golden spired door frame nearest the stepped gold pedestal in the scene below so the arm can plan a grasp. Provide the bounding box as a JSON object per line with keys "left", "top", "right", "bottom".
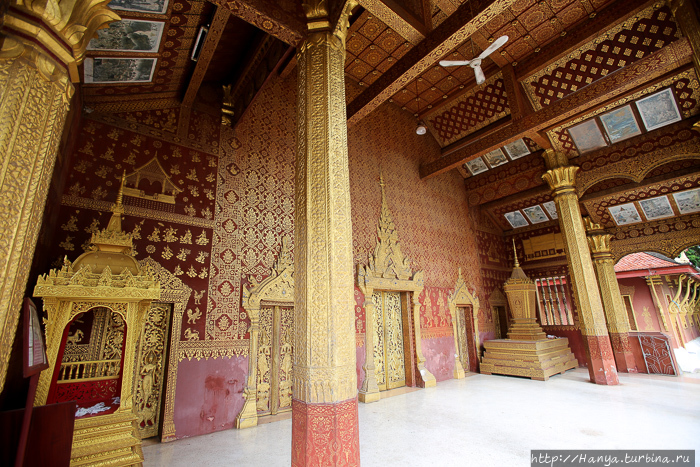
{"left": 447, "top": 268, "right": 479, "bottom": 379}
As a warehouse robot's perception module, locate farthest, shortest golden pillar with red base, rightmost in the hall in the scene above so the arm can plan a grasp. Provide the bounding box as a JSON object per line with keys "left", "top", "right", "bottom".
{"left": 584, "top": 217, "right": 637, "bottom": 373}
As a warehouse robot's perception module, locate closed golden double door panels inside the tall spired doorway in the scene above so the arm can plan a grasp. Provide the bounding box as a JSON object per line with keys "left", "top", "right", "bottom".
{"left": 372, "top": 291, "right": 406, "bottom": 391}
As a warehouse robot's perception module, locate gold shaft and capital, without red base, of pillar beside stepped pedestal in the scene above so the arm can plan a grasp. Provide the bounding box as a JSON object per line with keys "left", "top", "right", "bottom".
{"left": 542, "top": 166, "right": 608, "bottom": 336}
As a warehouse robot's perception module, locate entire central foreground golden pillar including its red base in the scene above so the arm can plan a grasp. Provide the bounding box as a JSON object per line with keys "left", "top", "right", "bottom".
{"left": 292, "top": 1, "right": 360, "bottom": 466}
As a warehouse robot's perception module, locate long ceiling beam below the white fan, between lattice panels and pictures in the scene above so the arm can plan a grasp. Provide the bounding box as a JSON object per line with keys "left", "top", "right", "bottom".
{"left": 420, "top": 38, "right": 692, "bottom": 178}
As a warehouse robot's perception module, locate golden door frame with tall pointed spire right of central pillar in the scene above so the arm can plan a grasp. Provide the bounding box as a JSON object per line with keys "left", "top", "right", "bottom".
{"left": 357, "top": 177, "right": 436, "bottom": 402}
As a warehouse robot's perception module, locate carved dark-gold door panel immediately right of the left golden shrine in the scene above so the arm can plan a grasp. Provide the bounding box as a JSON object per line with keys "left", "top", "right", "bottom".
{"left": 134, "top": 302, "right": 172, "bottom": 439}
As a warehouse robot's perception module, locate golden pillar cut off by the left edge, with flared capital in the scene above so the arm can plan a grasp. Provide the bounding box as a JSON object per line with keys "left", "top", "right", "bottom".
{"left": 0, "top": 0, "right": 119, "bottom": 390}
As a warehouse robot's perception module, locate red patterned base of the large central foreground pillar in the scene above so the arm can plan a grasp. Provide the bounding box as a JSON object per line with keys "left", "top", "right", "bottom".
{"left": 292, "top": 399, "right": 360, "bottom": 467}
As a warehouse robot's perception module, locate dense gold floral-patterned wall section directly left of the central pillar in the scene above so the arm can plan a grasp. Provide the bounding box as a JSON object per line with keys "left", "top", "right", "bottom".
{"left": 206, "top": 69, "right": 296, "bottom": 340}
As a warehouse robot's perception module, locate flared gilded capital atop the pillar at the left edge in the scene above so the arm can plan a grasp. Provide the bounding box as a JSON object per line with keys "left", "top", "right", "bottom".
{"left": 0, "top": 0, "right": 121, "bottom": 82}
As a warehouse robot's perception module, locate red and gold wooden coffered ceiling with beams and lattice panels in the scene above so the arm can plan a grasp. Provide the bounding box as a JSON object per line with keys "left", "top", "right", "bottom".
{"left": 82, "top": 0, "right": 700, "bottom": 238}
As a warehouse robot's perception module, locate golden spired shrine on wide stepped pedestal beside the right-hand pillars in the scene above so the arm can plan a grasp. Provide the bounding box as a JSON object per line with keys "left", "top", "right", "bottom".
{"left": 481, "top": 245, "right": 578, "bottom": 381}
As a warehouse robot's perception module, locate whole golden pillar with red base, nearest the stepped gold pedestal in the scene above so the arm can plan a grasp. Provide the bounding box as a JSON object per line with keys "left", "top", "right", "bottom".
{"left": 542, "top": 149, "right": 619, "bottom": 384}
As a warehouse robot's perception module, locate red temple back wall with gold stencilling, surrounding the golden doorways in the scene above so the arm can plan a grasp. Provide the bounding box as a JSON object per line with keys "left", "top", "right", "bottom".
{"left": 43, "top": 68, "right": 486, "bottom": 439}
